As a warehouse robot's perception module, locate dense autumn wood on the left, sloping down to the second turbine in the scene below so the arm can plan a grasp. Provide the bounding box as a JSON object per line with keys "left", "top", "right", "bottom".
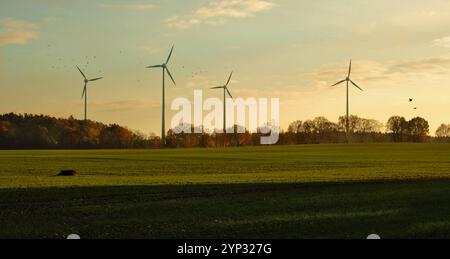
{"left": 0, "top": 113, "right": 161, "bottom": 149}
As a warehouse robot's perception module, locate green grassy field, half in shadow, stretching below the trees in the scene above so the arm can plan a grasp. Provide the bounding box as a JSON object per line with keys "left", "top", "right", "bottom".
{"left": 0, "top": 144, "right": 450, "bottom": 238}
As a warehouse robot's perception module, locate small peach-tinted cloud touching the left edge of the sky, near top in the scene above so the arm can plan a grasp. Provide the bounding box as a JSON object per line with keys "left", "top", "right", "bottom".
{"left": 0, "top": 18, "right": 38, "bottom": 47}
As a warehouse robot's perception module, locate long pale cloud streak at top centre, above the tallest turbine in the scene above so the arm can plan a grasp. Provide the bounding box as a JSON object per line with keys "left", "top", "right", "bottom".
{"left": 164, "top": 0, "right": 277, "bottom": 29}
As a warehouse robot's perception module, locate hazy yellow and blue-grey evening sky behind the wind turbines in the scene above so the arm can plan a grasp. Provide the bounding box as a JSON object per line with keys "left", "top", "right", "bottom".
{"left": 0, "top": 0, "right": 450, "bottom": 137}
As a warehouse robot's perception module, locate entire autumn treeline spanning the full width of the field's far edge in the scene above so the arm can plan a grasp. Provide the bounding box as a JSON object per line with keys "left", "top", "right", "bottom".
{"left": 0, "top": 113, "right": 450, "bottom": 149}
